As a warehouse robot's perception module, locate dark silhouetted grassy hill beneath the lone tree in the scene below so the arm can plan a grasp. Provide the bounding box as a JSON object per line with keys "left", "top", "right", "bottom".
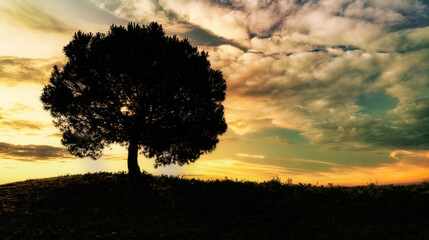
{"left": 0, "top": 173, "right": 429, "bottom": 240}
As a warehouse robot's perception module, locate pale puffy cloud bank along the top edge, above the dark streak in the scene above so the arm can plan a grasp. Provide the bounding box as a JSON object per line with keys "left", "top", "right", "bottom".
{"left": 89, "top": 0, "right": 429, "bottom": 49}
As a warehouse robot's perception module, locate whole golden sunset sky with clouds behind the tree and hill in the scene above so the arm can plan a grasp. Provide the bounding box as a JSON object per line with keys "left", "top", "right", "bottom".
{"left": 0, "top": 0, "right": 429, "bottom": 185}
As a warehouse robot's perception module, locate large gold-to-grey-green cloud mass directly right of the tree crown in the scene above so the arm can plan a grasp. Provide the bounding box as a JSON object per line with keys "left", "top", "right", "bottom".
{"left": 209, "top": 34, "right": 429, "bottom": 149}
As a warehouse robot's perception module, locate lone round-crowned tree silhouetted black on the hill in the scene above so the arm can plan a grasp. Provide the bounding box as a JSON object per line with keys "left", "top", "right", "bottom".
{"left": 41, "top": 23, "right": 227, "bottom": 182}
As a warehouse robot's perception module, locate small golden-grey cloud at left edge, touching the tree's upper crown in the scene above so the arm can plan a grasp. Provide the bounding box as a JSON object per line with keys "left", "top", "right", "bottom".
{"left": 0, "top": 56, "right": 64, "bottom": 86}
